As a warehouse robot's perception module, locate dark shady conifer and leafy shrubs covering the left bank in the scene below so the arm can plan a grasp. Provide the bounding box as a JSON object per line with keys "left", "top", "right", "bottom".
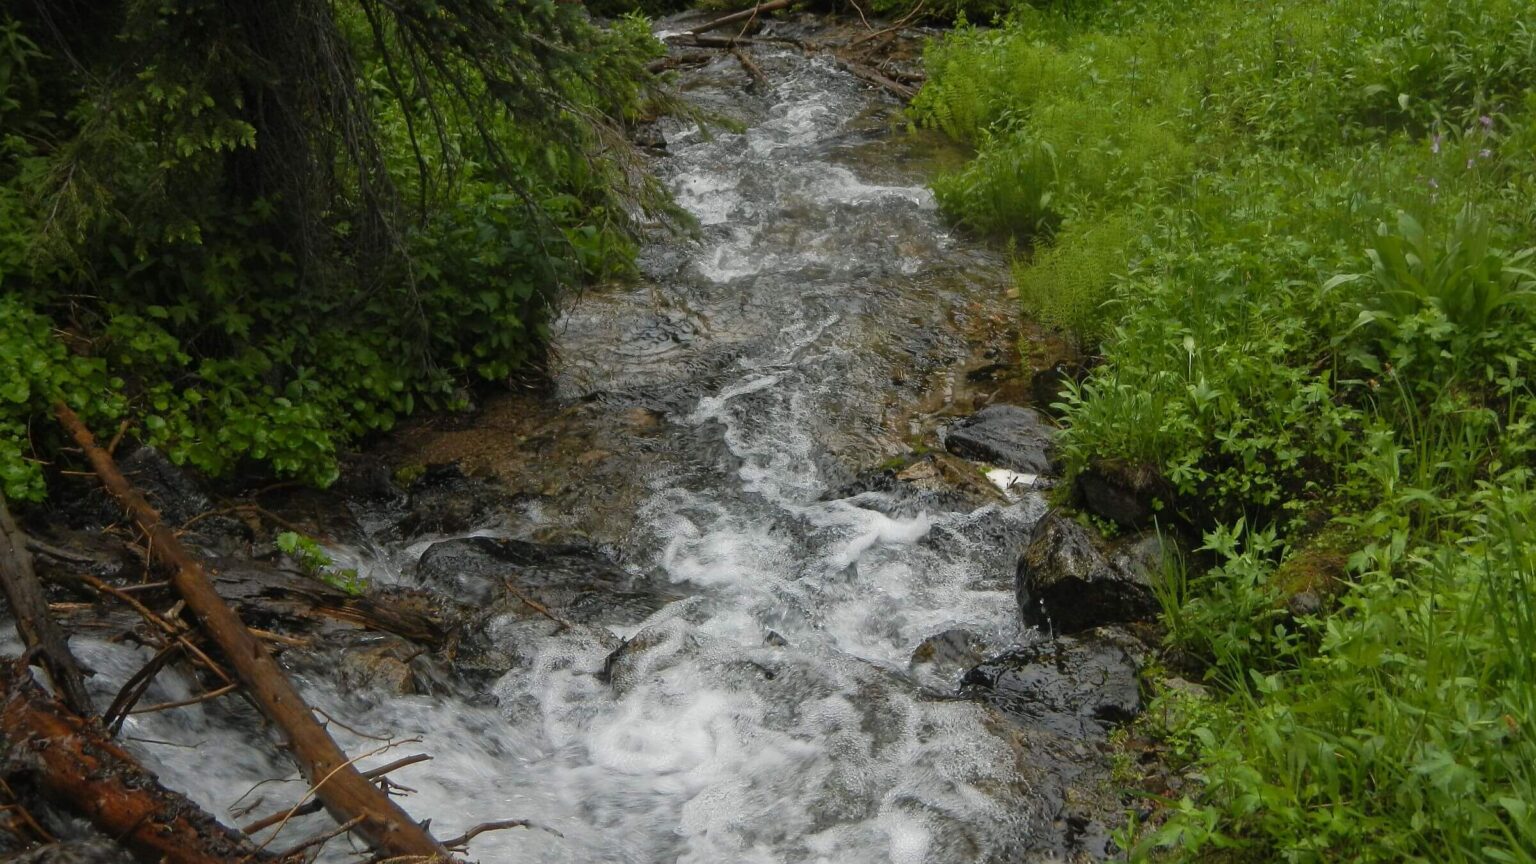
{"left": 0, "top": 0, "right": 660, "bottom": 500}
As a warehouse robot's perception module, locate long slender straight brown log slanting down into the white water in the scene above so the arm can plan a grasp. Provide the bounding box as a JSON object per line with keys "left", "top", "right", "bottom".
{"left": 54, "top": 403, "right": 450, "bottom": 859}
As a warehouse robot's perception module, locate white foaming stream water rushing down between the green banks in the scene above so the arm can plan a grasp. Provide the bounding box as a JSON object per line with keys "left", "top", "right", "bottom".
{"left": 12, "top": 26, "right": 1105, "bottom": 864}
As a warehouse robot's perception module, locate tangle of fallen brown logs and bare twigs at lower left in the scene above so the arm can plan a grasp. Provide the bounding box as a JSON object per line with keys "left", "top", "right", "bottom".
{"left": 0, "top": 403, "right": 527, "bottom": 864}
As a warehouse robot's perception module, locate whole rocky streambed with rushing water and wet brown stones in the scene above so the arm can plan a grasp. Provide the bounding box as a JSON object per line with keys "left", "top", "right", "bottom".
{"left": 6, "top": 15, "right": 1157, "bottom": 864}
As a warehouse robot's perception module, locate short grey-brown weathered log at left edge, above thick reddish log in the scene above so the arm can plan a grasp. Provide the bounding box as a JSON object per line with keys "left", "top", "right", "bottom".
{"left": 0, "top": 495, "right": 95, "bottom": 716}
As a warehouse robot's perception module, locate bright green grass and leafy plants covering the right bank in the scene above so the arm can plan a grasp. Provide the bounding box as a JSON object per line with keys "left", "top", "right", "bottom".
{"left": 914, "top": 0, "right": 1536, "bottom": 861}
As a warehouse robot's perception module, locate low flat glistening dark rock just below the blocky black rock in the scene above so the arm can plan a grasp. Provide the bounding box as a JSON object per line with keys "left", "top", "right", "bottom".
{"left": 960, "top": 627, "right": 1144, "bottom": 738}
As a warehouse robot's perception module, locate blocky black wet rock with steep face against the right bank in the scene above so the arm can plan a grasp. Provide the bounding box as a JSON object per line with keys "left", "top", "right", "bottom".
{"left": 1014, "top": 512, "right": 1163, "bottom": 633}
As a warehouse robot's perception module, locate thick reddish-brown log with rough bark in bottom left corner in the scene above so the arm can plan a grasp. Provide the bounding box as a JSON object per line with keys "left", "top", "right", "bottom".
{"left": 0, "top": 664, "right": 275, "bottom": 864}
